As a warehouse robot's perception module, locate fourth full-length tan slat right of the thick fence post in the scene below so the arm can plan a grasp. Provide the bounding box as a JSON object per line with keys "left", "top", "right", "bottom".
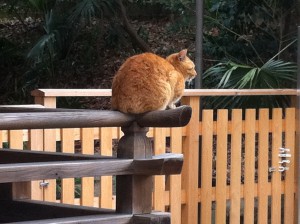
{"left": 244, "top": 109, "right": 255, "bottom": 224}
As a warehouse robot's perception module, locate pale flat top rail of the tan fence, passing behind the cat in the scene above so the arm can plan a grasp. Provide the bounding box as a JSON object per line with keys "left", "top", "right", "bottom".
{"left": 31, "top": 89, "right": 297, "bottom": 97}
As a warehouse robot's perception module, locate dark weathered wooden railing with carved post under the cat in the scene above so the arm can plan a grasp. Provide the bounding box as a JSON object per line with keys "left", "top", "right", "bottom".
{"left": 0, "top": 106, "right": 192, "bottom": 224}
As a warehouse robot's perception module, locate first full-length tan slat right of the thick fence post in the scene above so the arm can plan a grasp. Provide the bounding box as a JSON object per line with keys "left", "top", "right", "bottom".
{"left": 200, "top": 110, "right": 213, "bottom": 223}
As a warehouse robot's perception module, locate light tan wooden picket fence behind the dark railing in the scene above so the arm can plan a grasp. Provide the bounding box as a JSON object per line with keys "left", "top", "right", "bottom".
{"left": 0, "top": 89, "right": 297, "bottom": 224}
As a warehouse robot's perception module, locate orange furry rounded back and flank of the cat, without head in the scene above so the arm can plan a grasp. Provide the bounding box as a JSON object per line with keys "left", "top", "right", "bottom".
{"left": 112, "top": 53, "right": 174, "bottom": 113}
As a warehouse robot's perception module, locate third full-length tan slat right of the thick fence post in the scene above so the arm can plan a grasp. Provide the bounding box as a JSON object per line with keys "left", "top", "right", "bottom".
{"left": 230, "top": 109, "right": 242, "bottom": 224}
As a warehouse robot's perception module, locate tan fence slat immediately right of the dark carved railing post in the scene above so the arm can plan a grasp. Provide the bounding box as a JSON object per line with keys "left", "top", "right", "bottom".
{"left": 153, "top": 128, "right": 166, "bottom": 211}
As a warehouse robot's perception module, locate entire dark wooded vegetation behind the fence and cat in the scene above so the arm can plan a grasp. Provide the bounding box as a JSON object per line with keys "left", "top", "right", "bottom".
{"left": 0, "top": 0, "right": 297, "bottom": 108}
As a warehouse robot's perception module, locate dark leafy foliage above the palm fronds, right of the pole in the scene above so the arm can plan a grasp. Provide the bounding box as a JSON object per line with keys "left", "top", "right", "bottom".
{"left": 204, "top": 0, "right": 296, "bottom": 64}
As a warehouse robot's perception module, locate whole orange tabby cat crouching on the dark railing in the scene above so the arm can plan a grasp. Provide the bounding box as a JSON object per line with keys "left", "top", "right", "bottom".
{"left": 112, "top": 50, "right": 196, "bottom": 114}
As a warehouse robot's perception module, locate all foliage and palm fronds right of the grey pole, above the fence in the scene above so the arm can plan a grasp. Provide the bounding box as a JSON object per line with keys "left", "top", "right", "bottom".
{"left": 204, "top": 0, "right": 297, "bottom": 108}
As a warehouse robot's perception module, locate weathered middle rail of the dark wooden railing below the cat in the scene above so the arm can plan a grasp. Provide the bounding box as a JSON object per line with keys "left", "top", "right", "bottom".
{"left": 0, "top": 149, "right": 183, "bottom": 183}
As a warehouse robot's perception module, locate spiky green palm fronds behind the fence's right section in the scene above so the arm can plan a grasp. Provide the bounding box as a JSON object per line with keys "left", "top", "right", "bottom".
{"left": 204, "top": 59, "right": 297, "bottom": 108}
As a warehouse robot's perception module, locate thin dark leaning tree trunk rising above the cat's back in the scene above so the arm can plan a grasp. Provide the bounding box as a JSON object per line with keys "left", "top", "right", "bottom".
{"left": 117, "top": 0, "right": 152, "bottom": 52}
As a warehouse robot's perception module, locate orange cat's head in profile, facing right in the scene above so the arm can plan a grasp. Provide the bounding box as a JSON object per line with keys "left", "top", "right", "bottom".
{"left": 167, "top": 49, "right": 197, "bottom": 81}
